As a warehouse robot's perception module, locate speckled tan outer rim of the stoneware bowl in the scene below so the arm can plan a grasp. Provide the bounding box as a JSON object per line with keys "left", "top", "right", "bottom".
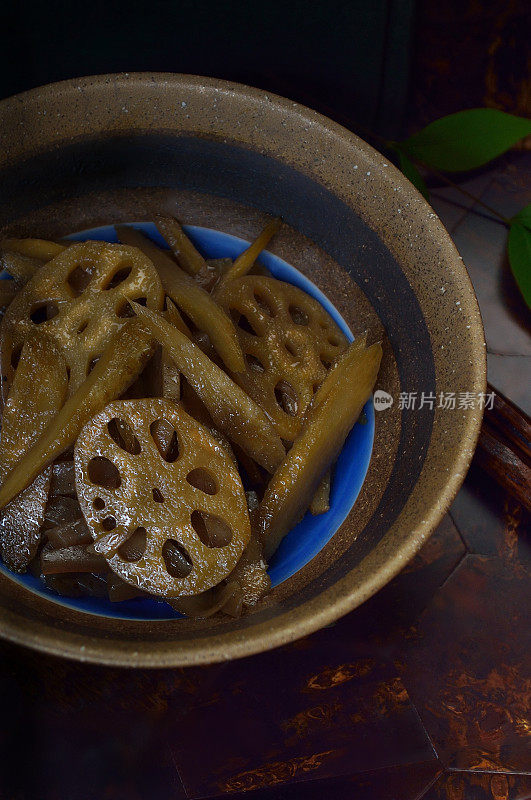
{"left": 0, "top": 73, "right": 486, "bottom": 667}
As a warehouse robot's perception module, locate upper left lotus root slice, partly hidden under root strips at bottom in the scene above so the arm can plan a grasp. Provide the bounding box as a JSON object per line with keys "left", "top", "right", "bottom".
{"left": 0, "top": 242, "right": 163, "bottom": 394}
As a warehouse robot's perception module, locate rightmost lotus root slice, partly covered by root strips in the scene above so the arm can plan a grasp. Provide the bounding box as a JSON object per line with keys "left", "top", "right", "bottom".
{"left": 216, "top": 275, "right": 348, "bottom": 441}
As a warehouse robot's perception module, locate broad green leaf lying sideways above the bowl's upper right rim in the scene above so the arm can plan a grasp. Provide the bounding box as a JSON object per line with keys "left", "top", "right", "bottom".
{"left": 399, "top": 108, "right": 531, "bottom": 172}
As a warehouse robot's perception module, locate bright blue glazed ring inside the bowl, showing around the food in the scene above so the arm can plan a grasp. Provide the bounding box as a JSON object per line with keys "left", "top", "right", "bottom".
{"left": 0, "top": 222, "right": 374, "bottom": 620}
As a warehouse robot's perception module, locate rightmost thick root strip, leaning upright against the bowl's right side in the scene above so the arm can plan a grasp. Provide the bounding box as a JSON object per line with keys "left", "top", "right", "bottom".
{"left": 258, "top": 344, "right": 382, "bottom": 558}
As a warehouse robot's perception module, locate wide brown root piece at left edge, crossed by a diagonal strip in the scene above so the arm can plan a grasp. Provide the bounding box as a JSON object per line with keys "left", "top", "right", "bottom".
{"left": 0, "top": 333, "right": 68, "bottom": 572}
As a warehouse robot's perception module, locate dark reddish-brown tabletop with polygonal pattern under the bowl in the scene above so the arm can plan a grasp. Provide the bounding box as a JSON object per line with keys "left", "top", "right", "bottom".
{"left": 0, "top": 154, "right": 531, "bottom": 800}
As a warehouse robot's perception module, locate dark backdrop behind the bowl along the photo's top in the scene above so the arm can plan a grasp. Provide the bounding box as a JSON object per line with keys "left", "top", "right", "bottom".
{"left": 0, "top": 0, "right": 530, "bottom": 137}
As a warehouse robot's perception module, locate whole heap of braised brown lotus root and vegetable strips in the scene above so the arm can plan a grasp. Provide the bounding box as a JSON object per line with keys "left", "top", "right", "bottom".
{"left": 0, "top": 219, "right": 381, "bottom": 617}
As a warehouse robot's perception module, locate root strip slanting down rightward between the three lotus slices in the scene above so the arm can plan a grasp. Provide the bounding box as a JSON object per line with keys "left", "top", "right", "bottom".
{"left": 132, "top": 303, "right": 284, "bottom": 472}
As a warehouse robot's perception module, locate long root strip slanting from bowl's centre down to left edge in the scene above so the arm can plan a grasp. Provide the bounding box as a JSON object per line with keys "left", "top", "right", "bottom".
{"left": 0, "top": 319, "right": 153, "bottom": 508}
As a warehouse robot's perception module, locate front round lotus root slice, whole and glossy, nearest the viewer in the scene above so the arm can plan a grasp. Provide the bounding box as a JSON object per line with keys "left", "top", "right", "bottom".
{"left": 75, "top": 399, "right": 254, "bottom": 597}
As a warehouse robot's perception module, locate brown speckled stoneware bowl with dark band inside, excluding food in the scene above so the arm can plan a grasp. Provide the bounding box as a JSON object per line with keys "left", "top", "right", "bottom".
{"left": 0, "top": 74, "right": 485, "bottom": 667}
